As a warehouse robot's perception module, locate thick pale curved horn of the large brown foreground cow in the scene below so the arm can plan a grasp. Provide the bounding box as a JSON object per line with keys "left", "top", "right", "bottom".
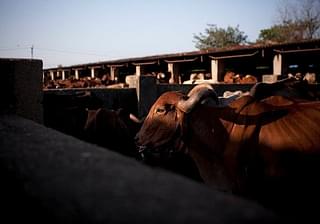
{"left": 177, "top": 84, "right": 219, "bottom": 113}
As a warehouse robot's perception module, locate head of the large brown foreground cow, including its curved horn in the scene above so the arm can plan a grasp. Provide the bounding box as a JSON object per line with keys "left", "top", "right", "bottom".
{"left": 136, "top": 84, "right": 218, "bottom": 159}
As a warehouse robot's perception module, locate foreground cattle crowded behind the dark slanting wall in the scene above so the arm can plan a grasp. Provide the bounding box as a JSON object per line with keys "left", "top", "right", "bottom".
{"left": 45, "top": 78, "right": 320, "bottom": 222}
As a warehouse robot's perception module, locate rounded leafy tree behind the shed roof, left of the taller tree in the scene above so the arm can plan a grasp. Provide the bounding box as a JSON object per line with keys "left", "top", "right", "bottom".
{"left": 193, "top": 24, "right": 247, "bottom": 50}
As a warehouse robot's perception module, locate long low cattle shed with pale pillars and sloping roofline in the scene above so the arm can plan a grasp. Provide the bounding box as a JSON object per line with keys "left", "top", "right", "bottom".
{"left": 43, "top": 39, "right": 320, "bottom": 84}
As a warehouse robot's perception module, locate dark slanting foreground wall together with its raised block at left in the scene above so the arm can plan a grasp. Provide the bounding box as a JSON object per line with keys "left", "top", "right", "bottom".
{"left": 0, "top": 59, "right": 279, "bottom": 223}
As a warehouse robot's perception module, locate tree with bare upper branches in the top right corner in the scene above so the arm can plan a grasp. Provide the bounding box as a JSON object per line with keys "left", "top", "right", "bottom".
{"left": 258, "top": 0, "right": 320, "bottom": 43}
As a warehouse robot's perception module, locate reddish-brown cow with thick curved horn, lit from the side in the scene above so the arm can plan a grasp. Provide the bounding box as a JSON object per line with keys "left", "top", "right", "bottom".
{"left": 136, "top": 84, "right": 320, "bottom": 219}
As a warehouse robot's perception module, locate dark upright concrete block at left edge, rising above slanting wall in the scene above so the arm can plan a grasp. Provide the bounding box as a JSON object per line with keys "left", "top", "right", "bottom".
{"left": 0, "top": 58, "right": 43, "bottom": 123}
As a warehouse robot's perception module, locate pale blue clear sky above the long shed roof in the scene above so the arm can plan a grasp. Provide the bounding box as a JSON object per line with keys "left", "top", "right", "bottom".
{"left": 0, "top": 0, "right": 280, "bottom": 68}
